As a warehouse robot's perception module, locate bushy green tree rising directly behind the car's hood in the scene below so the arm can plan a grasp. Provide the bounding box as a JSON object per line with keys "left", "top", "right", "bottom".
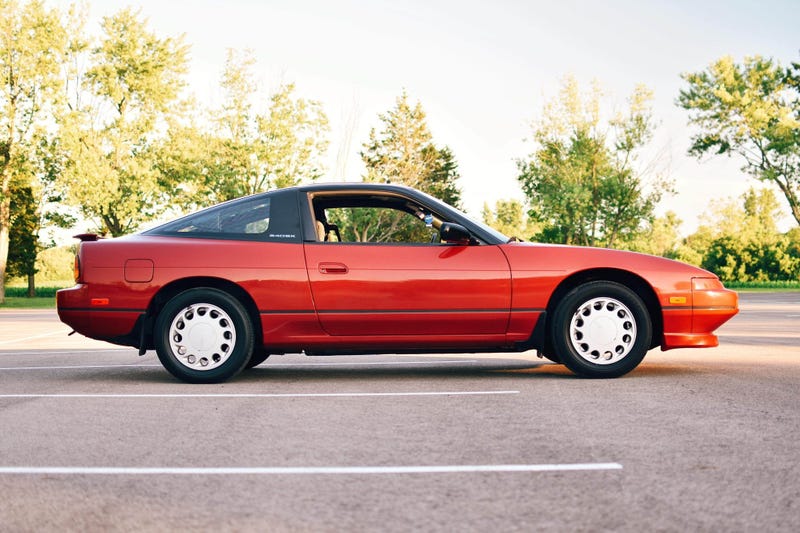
{"left": 517, "top": 77, "right": 668, "bottom": 247}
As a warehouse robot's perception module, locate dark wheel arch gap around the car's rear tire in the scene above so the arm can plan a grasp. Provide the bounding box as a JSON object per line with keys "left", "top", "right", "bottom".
{"left": 139, "top": 276, "right": 264, "bottom": 353}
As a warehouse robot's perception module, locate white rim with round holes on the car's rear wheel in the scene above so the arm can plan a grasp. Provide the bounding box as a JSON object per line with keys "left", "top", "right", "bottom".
{"left": 169, "top": 303, "right": 236, "bottom": 372}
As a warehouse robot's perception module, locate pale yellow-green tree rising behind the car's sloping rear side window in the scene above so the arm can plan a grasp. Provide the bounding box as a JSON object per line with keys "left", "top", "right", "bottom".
{"left": 160, "top": 50, "right": 329, "bottom": 208}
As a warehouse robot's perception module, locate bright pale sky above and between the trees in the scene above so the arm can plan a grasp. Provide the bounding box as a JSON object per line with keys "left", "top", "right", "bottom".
{"left": 51, "top": 0, "right": 800, "bottom": 233}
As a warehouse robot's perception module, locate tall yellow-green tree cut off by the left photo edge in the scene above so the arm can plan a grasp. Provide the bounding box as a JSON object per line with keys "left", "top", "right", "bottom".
{"left": 0, "top": 0, "right": 66, "bottom": 303}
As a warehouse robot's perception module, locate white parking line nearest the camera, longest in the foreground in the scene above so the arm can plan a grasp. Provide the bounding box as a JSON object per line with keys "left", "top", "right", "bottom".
{"left": 0, "top": 463, "right": 622, "bottom": 476}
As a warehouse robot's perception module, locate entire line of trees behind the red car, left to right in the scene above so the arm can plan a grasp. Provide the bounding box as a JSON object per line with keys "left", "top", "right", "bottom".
{"left": 0, "top": 0, "right": 800, "bottom": 303}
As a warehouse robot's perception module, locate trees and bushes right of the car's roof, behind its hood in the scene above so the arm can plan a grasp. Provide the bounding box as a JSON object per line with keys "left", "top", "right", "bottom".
{"left": 483, "top": 56, "right": 800, "bottom": 282}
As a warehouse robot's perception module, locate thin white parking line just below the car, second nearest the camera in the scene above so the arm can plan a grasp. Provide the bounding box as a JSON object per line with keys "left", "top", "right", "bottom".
{"left": 0, "top": 390, "right": 519, "bottom": 399}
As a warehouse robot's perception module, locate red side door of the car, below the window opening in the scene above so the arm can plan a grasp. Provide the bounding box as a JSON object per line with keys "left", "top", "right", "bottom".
{"left": 304, "top": 200, "right": 511, "bottom": 336}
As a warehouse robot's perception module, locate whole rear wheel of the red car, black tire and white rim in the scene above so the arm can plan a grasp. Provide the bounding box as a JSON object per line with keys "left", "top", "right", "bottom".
{"left": 154, "top": 288, "right": 254, "bottom": 383}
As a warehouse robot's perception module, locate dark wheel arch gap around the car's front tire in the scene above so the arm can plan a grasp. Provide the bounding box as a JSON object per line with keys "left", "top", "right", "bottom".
{"left": 542, "top": 268, "right": 664, "bottom": 352}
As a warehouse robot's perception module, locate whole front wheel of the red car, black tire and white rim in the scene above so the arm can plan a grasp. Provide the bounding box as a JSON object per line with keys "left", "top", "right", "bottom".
{"left": 550, "top": 281, "right": 653, "bottom": 378}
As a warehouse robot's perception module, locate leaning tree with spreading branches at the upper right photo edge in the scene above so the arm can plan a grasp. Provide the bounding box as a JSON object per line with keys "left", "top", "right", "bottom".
{"left": 678, "top": 56, "right": 800, "bottom": 224}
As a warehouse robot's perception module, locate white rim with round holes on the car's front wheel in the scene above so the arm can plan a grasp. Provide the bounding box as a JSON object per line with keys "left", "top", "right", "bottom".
{"left": 569, "top": 297, "right": 636, "bottom": 365}
